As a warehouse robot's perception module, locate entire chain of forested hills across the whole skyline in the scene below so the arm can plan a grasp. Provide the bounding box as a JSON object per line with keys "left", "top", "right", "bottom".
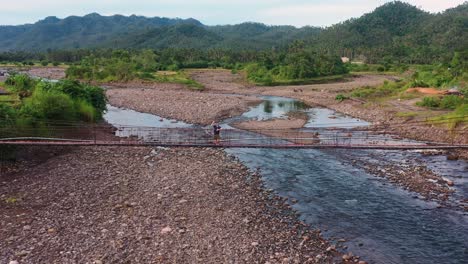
{"left": 0, "top": 1, "right": 468, "bottom": 63}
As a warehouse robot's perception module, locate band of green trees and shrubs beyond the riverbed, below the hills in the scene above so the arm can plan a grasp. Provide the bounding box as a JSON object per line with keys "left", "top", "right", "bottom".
{"left": 61, "top": 42, "right": 348, "bottom": 86}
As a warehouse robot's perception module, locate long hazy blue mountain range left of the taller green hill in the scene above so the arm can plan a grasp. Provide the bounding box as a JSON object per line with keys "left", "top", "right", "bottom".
{"left": 0, "top": 14, "right": 320, "bottom": 51}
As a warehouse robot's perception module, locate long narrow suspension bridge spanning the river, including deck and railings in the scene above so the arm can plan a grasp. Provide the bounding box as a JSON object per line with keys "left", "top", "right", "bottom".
{"left": 0, "top": 125, "right": 468, "bottom": 150}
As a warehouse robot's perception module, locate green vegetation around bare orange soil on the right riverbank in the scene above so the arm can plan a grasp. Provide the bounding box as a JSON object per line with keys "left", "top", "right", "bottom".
{"left": 336, "top": 52, "right": 468, "bottom": 129}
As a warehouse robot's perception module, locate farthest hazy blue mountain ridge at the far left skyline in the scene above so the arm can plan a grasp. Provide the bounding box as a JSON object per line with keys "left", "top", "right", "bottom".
{"left": 0, "top": 13, "right": 202, "bottom": 51}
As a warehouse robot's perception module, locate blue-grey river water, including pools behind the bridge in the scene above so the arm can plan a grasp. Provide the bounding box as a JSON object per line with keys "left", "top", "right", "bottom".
{"left": 105, "top": 97, "right": 468, "bottom": 264}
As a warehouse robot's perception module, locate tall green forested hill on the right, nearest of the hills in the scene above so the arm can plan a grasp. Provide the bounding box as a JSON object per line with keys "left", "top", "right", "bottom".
{"left": 313, "top": 1, "right": 468, "bottom": 63}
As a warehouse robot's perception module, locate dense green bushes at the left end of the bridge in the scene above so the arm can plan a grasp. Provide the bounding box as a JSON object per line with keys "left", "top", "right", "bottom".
{"left": 0, "top": 74, "right": 106, "bottom": 135}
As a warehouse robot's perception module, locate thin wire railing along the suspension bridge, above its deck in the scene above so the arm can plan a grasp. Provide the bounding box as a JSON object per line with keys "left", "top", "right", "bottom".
{"left": 0, "top": 124, "right": 438, "bottom": 147}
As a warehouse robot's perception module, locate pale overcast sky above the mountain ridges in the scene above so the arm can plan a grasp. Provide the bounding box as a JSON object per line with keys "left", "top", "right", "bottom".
{"left": 0, "top": 0, "right": 466, "bottom": 26}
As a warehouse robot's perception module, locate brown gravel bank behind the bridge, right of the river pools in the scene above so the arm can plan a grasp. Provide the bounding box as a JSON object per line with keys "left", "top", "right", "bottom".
{"left": 192, "top": 70, "right": 468, "bottom": 145}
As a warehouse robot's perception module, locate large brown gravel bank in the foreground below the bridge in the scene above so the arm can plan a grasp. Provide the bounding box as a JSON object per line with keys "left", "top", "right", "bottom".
{"left": 0, "top": 147, "right": 336, "bottom": 263}
